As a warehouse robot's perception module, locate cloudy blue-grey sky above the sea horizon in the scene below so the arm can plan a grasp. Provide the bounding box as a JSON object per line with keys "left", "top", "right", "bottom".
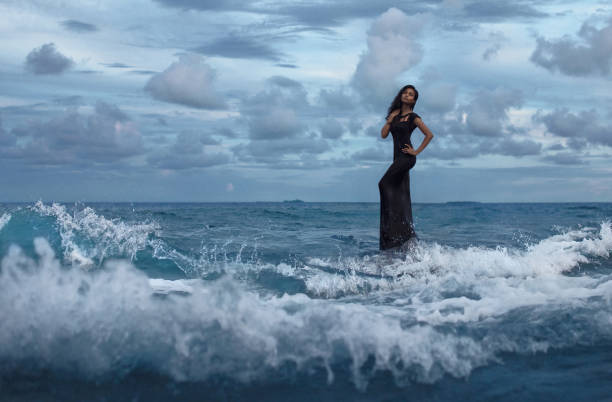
{"left": 0, "top": 0, "right": 612, "bottom": 202}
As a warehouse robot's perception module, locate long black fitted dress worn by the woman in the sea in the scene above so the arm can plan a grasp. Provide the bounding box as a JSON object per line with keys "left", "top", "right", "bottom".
{"left": 378, "top": 112, "right": 419, "bottom": 250}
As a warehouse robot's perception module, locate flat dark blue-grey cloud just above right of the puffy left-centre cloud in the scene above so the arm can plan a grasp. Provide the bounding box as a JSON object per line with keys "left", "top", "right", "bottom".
{"left": 194, "top": 34, "right": 284, "bottom": 61}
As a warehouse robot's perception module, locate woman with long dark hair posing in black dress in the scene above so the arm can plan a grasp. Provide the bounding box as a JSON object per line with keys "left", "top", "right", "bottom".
{"left": 378, "top": 85, "right": 433, "bottom": 250}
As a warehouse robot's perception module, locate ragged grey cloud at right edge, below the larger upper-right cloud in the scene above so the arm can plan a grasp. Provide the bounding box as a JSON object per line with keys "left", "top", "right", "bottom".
{"left": 533, "top": 108, "right": 612, "bottom": 149}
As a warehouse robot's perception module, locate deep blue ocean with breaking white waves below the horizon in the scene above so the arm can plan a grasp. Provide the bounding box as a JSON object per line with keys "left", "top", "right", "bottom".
{"left": 0, "top": 201, "right": 612, "bottom": 401}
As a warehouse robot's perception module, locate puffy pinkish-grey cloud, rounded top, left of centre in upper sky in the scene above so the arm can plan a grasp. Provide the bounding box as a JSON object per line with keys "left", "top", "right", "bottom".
{"left": 144, "top": 55, "right": 227, "bottom": 109}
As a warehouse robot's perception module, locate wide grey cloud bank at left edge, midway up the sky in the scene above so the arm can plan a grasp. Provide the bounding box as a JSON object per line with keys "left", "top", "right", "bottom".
{"left": 0, "top": 101, "right": 143, "bottom": 166}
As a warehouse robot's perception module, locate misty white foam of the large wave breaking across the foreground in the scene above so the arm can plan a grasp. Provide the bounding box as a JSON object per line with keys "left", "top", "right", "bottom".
{"left": 0, "top": 239, "right": 544, "bottom": 387}
